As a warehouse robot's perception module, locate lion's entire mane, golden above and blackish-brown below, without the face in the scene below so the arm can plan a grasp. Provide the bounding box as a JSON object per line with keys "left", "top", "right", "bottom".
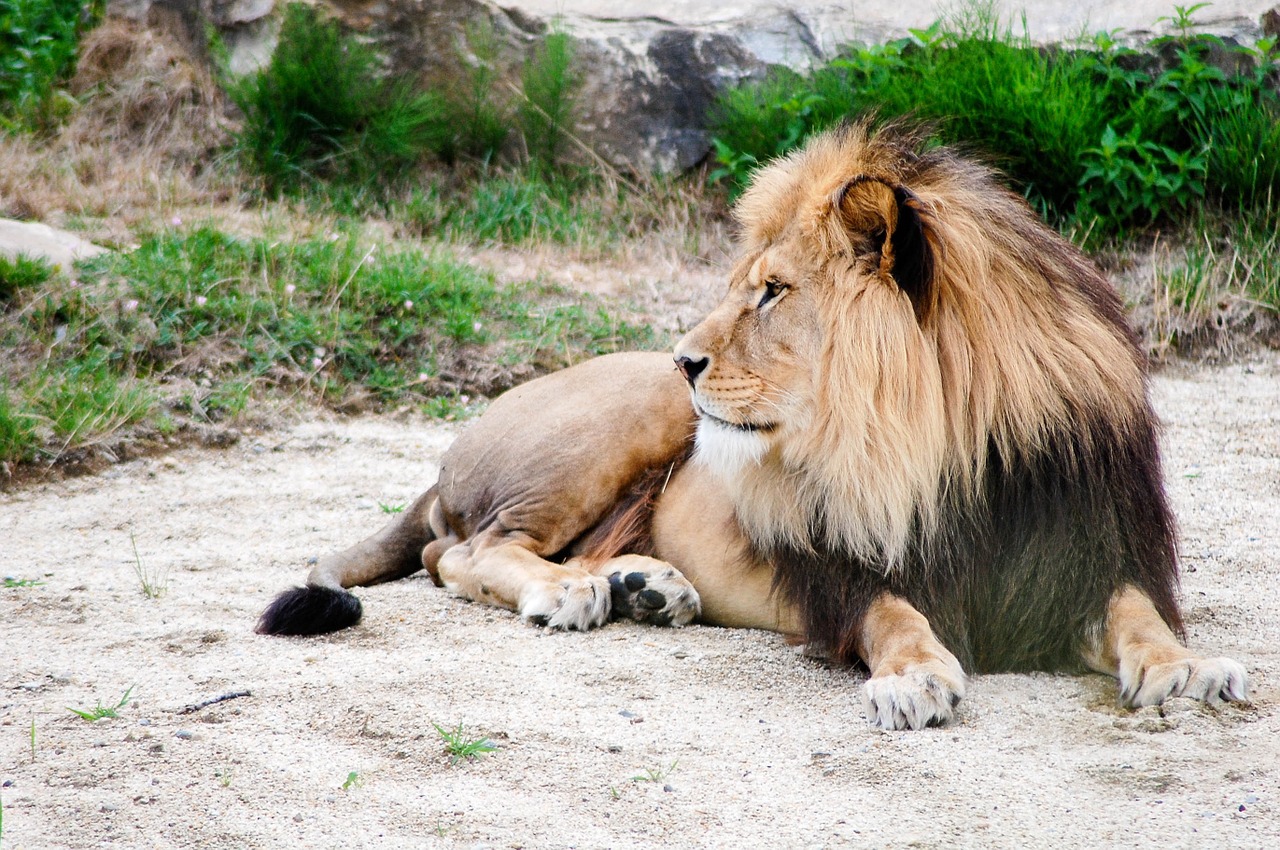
{"left": 733, "top": 124, "right": 1181, "bottom": 671}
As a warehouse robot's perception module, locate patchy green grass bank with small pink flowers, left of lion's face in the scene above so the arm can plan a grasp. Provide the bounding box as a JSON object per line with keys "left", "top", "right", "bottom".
{"left": 0, "top": 227, "right": 653, "bottom": 461}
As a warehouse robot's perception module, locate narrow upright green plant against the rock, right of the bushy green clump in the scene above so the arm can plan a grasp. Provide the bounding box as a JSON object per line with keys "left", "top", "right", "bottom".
{"left": 520, "top": 31, "right": 581, "bottom": 168}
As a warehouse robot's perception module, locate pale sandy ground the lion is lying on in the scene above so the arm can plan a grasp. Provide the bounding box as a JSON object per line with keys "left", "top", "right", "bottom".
{"left": 0, "top": 356, "right": 1280, "bottom": 850}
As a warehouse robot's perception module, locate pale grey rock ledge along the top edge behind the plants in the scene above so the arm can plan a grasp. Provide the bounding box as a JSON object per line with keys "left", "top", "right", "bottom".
{"left": 109, "top": 0, "right": 1275, "bottom": 172}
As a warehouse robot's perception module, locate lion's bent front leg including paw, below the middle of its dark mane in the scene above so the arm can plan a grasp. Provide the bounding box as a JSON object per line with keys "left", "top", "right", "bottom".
{"left": 858, "top": 593, "right": 965, "bottom": 730}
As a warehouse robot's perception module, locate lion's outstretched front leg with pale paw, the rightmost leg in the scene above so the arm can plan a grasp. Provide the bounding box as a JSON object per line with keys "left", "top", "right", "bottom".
{"left": 1084, "top": 585, "right": 1248, "bottom": 707}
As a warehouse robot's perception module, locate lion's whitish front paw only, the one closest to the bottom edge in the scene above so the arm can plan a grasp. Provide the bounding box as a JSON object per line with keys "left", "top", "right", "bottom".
{"left": 863, "top": 661, "right": 964, "bottom": 730}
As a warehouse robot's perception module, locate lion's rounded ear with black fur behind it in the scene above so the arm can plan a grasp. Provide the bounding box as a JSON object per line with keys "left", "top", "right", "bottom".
{"left": 833, "top": 175, "right": 933, "bottom": 319}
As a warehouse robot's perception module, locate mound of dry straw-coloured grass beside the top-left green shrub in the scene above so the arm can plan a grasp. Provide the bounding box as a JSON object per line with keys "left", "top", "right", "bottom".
{"left": 0, "top": 19, "right": 237, "bottom": 243}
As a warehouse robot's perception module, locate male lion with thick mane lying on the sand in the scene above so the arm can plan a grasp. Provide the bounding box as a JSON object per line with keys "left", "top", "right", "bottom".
{"left": 259, "top": 124, "right": 1245, "bottom": 728}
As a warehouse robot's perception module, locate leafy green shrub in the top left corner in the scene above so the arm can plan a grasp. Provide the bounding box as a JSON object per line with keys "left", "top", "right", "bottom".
{"left": 0, "top": 0, "right": 105, "bottom": 131}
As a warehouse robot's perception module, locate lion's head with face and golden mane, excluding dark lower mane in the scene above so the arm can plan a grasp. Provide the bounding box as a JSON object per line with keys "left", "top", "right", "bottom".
{"left": 676, "top": 123, "right": 1147, "bottom": 571}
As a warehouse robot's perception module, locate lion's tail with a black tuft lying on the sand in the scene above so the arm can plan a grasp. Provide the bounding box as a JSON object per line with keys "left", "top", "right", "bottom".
{"left": 255, "top": 486, "right": 436, "bottom": 635}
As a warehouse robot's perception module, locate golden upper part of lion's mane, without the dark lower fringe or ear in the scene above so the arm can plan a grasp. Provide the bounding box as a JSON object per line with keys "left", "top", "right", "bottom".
{"left": 736, "top": 123, "right": 1146, "bottom": 563}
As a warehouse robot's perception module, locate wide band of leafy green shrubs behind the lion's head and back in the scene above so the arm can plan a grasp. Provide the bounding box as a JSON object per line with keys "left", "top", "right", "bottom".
{"left": 712, "top": 6, "right": 1280, "bottom": 234}
